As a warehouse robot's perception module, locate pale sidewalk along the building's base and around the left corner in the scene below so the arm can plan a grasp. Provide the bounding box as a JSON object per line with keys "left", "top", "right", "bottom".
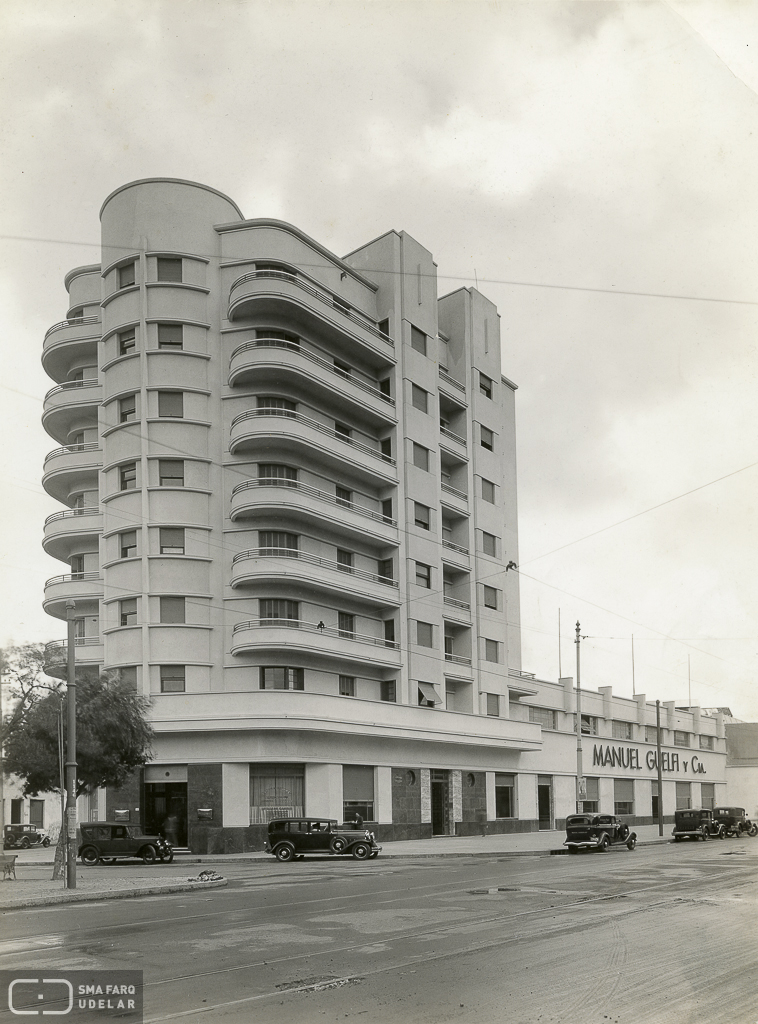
{"left": 0, "top": 825, "right": 671, "bottom": 910}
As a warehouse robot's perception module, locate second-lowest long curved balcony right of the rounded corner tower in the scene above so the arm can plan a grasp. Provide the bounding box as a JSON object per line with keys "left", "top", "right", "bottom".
{"left": 231, "top": 548, "right": 399, "bottom": 608}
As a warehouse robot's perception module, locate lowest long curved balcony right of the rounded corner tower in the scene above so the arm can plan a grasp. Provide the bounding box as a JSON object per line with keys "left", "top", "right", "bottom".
{"left": 231, "top": 618, "right": 401, "bottom": 669}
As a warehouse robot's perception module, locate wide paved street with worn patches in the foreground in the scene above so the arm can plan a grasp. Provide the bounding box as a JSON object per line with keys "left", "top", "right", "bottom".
{"left": 0, "top": 840, "right": 758, "bottom": 1024}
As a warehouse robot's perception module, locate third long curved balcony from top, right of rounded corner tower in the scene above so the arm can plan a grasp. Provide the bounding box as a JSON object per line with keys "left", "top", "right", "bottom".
{"left": 229, "top": 409, "right": 396, "bottom": 483}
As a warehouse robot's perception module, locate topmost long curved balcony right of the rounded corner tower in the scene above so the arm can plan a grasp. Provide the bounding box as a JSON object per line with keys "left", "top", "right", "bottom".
{"left": 228, "top": 269, "right": 394, "bottom": 365}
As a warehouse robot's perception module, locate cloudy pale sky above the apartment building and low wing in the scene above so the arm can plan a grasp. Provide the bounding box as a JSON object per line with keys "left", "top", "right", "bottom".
{"left": 0, "top": 0, "right": 758, "bottom": 721}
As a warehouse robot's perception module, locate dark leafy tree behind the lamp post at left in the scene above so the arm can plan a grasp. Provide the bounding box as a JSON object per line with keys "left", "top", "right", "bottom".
{"left": 4, "top": 676, "right": 153, "bottom": 878}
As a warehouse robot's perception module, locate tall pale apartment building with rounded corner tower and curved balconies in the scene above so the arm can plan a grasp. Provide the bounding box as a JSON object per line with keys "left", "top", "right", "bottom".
{"left": 43, "top": 178, "right": 542, "bottom": 851}
